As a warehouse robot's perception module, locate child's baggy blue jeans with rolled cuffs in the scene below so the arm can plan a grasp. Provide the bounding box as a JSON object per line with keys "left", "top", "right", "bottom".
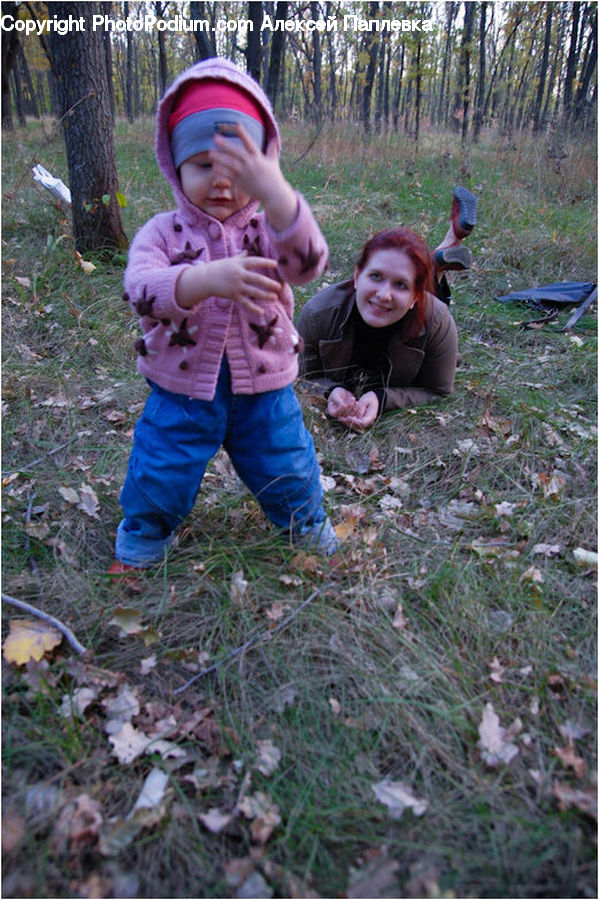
{"left": 116, "top": 359, "right": 337, "bottom": 566}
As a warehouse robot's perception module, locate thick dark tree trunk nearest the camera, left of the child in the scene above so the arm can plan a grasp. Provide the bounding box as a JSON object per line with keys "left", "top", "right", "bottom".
{"left": 48, "top": 2, "right": 128, "bottom": 253}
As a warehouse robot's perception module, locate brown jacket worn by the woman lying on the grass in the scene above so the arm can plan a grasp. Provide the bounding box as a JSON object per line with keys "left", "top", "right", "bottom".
{"left": 297, "top": 279, "right": 458, "bottom": 411}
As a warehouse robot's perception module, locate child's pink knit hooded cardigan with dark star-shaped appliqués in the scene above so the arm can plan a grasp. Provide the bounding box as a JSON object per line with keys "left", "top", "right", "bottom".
{"left": 124, "top": 59, "right": 328, "bottom": 400}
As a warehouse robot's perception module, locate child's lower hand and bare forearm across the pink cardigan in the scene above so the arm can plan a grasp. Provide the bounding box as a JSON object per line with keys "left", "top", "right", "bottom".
{"left": 175, "top": 253, "right": 282, "bottom": 315}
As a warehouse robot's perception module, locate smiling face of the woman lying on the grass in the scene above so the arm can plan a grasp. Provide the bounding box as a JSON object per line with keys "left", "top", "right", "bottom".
{"left": 354, "top": 249, "right": 416, "bottom": 328}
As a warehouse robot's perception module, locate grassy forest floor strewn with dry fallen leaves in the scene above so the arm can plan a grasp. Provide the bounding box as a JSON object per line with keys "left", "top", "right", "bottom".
{"left": 2, "top": 116, "right": 596, "bottom": 897}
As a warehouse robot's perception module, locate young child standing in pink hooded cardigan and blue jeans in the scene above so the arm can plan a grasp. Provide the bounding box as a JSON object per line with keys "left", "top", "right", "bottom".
{"left": 110, "top": 59, "right": 337, "bottom": 574}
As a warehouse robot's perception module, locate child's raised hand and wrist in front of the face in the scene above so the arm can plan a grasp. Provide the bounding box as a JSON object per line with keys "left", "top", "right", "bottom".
{"left": 209, "top": 124, "right": 297, "bottom": 231}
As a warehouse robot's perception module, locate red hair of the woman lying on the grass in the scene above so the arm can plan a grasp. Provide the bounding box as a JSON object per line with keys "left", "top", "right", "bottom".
{"left": 356, "top": 228, "right": 433, "bottom": 337}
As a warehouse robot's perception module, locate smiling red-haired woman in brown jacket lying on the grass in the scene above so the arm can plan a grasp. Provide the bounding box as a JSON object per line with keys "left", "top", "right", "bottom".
{"left": 297, "top": 188, "right": 476, "bottom": 432}
